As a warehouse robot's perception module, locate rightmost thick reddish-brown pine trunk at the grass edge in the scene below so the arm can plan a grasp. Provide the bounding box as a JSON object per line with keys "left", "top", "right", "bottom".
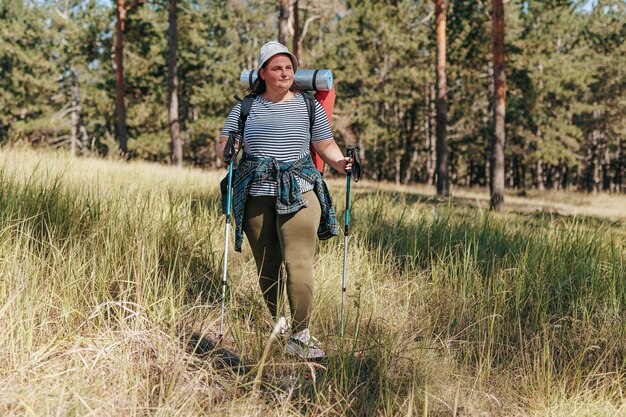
{"left": 489, "top": 0, "right": 506, "bottom": 211}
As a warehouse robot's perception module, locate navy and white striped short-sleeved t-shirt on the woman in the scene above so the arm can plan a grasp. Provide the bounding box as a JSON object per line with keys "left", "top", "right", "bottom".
{"left": 221, "top": 93, "right": 333, "bottom": 196}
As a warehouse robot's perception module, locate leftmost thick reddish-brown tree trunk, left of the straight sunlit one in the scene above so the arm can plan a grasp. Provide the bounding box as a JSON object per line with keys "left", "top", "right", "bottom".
{"left": 115, "top": 0, "right": 128, "bottom": 156}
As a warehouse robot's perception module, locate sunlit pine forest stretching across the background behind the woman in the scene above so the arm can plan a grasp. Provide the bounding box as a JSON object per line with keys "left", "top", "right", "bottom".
{"left": 0, "top": 0, "right": 626, "bottom": 194}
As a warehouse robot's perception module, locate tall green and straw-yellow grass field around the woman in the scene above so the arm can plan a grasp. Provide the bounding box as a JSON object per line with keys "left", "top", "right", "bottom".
{"left": 0, "top": 149, "right": 626, "bottom": 416}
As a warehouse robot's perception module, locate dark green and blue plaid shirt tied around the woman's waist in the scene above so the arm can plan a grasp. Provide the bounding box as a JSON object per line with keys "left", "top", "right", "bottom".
{"left": 222, "top": 152, "right": 339, "bottom": 252}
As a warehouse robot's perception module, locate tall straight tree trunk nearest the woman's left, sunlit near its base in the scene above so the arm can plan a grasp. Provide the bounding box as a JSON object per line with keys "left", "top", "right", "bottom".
{"left": 167, "top": 0, "right": 183, "bottom": 167}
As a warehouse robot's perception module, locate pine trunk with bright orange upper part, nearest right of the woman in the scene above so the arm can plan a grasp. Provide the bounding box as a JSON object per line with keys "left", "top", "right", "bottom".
{"left": 435, "top": 0, "right": 450, "bottom": 196}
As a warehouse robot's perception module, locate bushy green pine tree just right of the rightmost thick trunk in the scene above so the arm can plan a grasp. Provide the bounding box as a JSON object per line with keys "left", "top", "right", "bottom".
{"left": 511, "top": 2, "right": 591, "bottom": 189}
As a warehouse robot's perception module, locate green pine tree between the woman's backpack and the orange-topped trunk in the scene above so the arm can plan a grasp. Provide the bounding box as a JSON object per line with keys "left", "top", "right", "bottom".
{"left": 322, "top": 1, "right": 434, "bottom": 183}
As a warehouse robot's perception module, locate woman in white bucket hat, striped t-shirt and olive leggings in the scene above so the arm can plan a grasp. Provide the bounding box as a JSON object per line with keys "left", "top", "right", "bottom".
{"left": 217, "top": 42, "right": 351, "bottom": 359}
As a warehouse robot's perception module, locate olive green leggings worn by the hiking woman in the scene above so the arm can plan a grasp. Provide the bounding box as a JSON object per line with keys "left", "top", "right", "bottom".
{"left": 243, "top": 191, "right": 321, "bottom": 332}
